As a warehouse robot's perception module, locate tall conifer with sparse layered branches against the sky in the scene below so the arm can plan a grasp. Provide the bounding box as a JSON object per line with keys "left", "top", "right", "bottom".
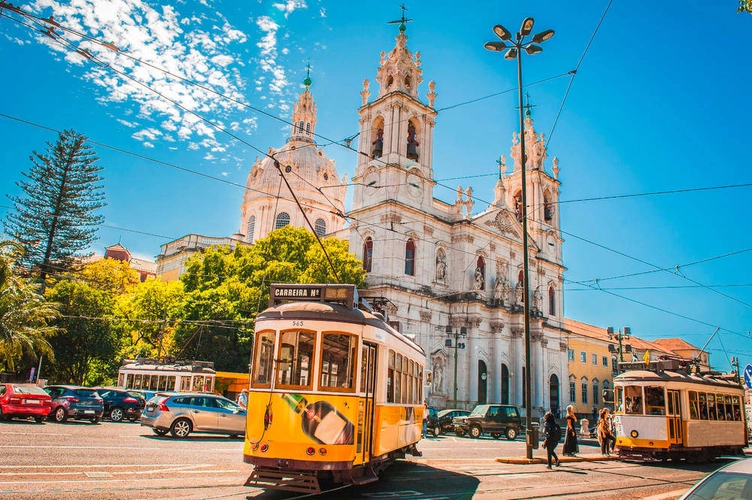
{"left": 5, "top": 130, "right": 105, "bottom": 290}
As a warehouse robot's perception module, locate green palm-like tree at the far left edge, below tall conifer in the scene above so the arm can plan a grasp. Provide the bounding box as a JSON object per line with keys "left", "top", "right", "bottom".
{"left": 0, "top": 241, "right": 58, "bottom": 371}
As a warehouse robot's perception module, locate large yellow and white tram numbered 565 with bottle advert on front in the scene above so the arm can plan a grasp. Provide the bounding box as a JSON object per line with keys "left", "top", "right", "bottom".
{"left": 243, "top": 284, "right": 425, "bottom": 492}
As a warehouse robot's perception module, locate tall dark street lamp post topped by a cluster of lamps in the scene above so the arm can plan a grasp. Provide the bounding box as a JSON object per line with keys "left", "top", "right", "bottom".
{"left": 484, "top": 17, "right": 554, "bottom": 459}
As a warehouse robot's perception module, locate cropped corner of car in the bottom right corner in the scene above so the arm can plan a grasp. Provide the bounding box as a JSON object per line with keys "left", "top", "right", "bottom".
{"left": 679, "top": 458, "right": 752, "bottom": 500}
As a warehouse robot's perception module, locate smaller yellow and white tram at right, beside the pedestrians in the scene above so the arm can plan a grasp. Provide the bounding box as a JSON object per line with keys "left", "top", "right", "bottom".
{"left": 613, "top": 362, "right": 747, "bottom": 462}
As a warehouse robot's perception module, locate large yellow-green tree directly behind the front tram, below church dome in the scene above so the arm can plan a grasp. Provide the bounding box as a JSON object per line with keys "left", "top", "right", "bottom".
{"left": 173, "top": 226, "right": 365, "bottom": 371}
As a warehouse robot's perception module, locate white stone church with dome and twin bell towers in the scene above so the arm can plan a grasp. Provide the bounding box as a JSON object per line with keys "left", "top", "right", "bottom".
{"left": 232, "top": 24, "right": 568, "bottom": 416}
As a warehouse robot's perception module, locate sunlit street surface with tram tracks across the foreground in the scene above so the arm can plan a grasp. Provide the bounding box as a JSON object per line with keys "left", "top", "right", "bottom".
{"left": 0, "top": 421, "right": 740, "bottom": 500}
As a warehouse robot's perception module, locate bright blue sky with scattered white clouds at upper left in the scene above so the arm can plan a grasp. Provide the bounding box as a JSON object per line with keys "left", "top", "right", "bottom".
{"left": 0, "top": 0, "right": 752, "bottom": 376}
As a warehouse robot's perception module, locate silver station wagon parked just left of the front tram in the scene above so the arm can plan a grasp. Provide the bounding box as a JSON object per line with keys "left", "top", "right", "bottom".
{"left": 141, "top": 393, "right": 246, "bottom": 438}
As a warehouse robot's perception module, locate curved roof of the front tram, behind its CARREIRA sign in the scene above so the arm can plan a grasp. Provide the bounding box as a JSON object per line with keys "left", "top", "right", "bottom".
{"left": 256, "top": 302, "right": 423, "bottom": 352}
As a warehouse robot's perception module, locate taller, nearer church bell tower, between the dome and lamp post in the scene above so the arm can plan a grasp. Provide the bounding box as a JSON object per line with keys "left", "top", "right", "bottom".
{"left": 353, "top": 11, "right": 438, "bottom": 209}
